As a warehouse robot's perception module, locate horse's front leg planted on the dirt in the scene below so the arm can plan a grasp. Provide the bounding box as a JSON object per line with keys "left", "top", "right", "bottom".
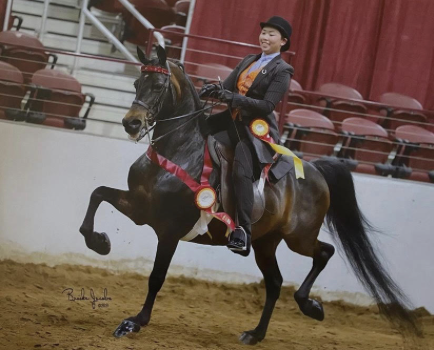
{"left": 113, "top": 237, "right": 179, "bottom": 338}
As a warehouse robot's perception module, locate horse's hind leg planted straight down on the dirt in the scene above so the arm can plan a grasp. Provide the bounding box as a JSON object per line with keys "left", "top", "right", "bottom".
{"left": 240, "top": 235, "right": 283, "bottom": 345}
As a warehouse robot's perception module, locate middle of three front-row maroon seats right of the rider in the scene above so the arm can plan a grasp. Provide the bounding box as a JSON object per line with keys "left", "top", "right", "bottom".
{"left": 338, "top": 117, "right": 393, "bottom": 175}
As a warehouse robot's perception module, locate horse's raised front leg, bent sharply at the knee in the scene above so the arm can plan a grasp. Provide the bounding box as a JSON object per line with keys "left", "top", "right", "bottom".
{"left": 80, "top": 186, "right": 134, "bottom": 255}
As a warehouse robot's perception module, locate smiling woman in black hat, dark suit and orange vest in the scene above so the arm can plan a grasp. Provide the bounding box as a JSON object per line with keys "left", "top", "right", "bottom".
{"left": 199, "top": 16, "right": 294, "bottom": 256}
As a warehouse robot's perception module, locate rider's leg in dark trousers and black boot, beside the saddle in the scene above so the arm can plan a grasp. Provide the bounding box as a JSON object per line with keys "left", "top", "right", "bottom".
{"left": 227, "top": 141, "right": 254, "bottom": 256}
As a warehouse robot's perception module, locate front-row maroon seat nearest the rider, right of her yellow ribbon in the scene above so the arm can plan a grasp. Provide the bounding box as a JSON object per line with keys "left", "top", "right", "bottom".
{"left": 283, "top": 109, "right": 339, "bottom": 161}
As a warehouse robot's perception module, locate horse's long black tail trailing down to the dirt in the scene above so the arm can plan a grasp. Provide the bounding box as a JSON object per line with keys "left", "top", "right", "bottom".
{"left": 313, "top": 160, "right": 421, "bottom": 335}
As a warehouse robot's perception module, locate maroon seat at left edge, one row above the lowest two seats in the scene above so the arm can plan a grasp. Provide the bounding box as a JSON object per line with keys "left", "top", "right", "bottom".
{"left": 0, "top": 31, "right": 57, "bottom": 83}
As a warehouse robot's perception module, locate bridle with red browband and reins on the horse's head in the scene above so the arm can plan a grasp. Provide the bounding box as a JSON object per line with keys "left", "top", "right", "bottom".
{"left": 133, "top": 61, "right": 221, "bottom": 145}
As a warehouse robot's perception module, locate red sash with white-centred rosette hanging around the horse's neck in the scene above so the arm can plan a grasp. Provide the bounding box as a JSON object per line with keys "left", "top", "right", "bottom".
{"left": 146, "top": 141, "right": 235, "bottom": 232}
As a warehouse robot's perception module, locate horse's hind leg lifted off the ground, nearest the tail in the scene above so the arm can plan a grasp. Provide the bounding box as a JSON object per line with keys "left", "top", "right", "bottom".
{"left": 286, "top": 235, "right": 335, "bottom": 321}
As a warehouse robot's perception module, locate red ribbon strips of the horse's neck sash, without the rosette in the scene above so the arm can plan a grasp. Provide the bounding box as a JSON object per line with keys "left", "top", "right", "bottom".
{"left": 146, "top": 141, "right": 235, "bottom": 231}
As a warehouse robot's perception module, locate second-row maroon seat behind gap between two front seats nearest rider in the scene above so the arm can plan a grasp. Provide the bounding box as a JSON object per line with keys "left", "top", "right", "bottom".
{"left": 317, "top": 83, "right": 367, "bottom": 128}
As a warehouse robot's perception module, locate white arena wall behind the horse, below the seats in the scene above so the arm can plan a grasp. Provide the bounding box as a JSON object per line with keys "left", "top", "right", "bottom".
{"left": 0, "top": 121, "right": 434, "bottom": 313}
